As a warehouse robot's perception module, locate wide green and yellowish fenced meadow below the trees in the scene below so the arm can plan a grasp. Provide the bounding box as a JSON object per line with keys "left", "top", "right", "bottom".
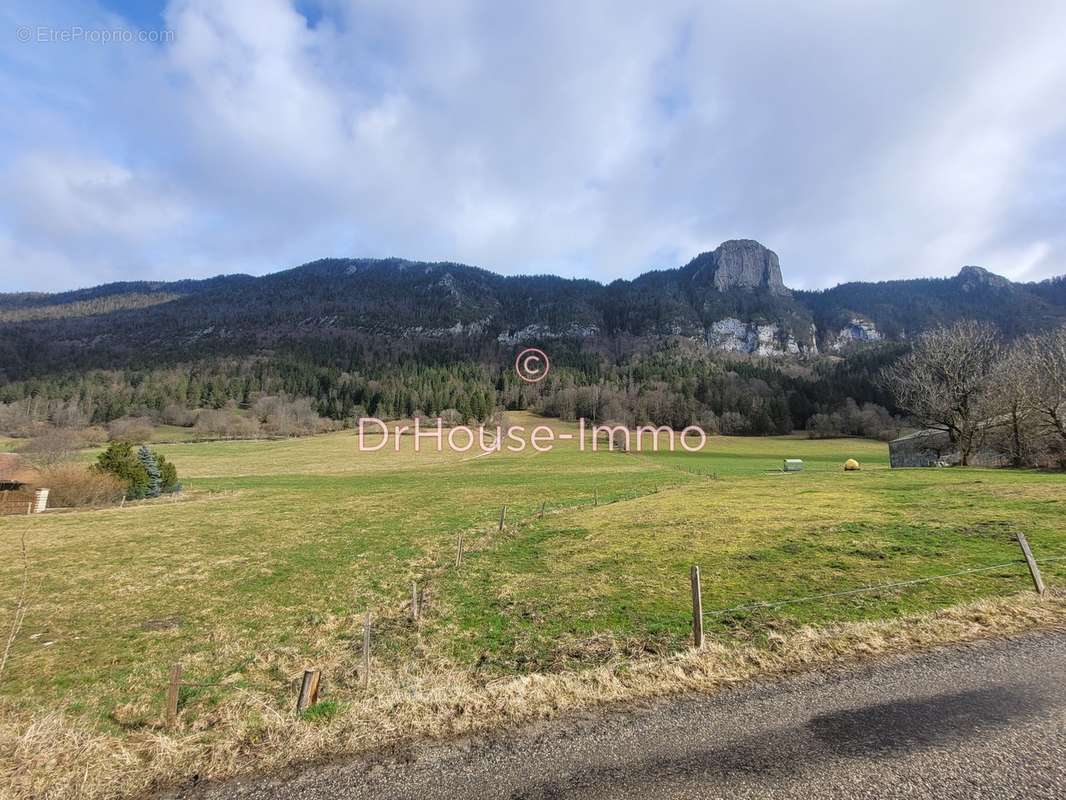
{"left": 0, "top": 415, "right": 1066, "bottom": 796}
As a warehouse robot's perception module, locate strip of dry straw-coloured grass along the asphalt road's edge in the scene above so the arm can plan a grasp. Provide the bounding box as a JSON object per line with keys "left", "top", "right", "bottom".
{"left": 0, "top": 591, "right": 1066, "bottom": 800}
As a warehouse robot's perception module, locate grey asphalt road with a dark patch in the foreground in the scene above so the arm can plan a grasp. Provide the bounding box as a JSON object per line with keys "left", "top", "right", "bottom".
{"left": 171, "top": 633, "right": 1066, "bottom": 800}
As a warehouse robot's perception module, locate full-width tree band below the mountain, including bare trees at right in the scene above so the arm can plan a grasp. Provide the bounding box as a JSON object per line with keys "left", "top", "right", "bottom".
{"left": 0, "top": 321, "right": 1066, "bottom": 466}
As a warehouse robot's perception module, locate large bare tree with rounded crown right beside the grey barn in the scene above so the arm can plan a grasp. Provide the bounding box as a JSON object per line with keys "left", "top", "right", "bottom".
{"left": 884, "top": 321, "right": 1003, "bottom": 466}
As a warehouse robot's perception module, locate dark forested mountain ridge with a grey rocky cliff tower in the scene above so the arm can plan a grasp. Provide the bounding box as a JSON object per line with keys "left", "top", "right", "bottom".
{"left": 0, "top": 239, "right": 1066, "bottom": 380}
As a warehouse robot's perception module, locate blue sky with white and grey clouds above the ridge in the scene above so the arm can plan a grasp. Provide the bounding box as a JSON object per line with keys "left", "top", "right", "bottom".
{"left": 0, "top": 0, "right": 1066, "bottom": 291}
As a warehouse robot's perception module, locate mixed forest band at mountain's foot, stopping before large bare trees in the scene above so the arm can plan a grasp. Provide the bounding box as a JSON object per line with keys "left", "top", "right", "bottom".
{"left": 0, "top": 339, "right": 899, "bottom": 438}
